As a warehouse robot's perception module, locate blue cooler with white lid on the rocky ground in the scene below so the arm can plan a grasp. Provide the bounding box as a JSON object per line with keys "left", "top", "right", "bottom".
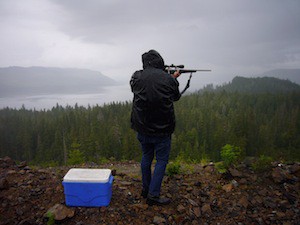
{"left": 62, "top": 168, "right": 114, "bottom": 207}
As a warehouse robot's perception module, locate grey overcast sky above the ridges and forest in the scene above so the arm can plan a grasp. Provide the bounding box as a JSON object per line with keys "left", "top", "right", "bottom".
{"left": 0, "top": 0, "right": 300, "bottom": 86}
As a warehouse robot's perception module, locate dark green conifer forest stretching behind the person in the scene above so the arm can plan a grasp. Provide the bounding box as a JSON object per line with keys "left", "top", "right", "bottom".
{"left": 0, "top": 77, "right": 300, "bottom": 165}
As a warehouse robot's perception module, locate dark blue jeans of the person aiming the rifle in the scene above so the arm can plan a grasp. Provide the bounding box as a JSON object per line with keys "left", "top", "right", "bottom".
{"left": 137, "top": 133, "right": 171, "bottom": 196}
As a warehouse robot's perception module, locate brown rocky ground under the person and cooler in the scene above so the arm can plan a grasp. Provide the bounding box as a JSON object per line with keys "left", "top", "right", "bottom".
{"left": 0, "top": 157, "right": 300, "bottom": 225}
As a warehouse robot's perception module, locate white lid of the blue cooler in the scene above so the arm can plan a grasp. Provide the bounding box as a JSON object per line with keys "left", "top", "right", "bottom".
{"left": 63, "top": 168, "right": 111, "bottom": 183}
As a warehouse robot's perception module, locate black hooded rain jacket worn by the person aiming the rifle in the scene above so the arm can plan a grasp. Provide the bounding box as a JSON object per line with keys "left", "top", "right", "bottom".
{"left": 130, "top": 50, "right": 181, "bottom": 136}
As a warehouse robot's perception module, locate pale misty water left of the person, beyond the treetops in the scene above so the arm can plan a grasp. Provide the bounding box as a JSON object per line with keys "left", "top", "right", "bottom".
{"left": 0, "top": 84, "right": 133, "bottom": 110}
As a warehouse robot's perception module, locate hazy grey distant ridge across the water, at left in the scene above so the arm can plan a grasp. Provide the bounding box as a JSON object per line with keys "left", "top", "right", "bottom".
{"left": 0, "top": 67, "right": 117, "bottom": 97}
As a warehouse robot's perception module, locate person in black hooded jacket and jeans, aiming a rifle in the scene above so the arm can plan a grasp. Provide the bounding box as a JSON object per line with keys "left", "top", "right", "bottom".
{"left": 130, "top": 50, "right": 181, "bottom": 205}
